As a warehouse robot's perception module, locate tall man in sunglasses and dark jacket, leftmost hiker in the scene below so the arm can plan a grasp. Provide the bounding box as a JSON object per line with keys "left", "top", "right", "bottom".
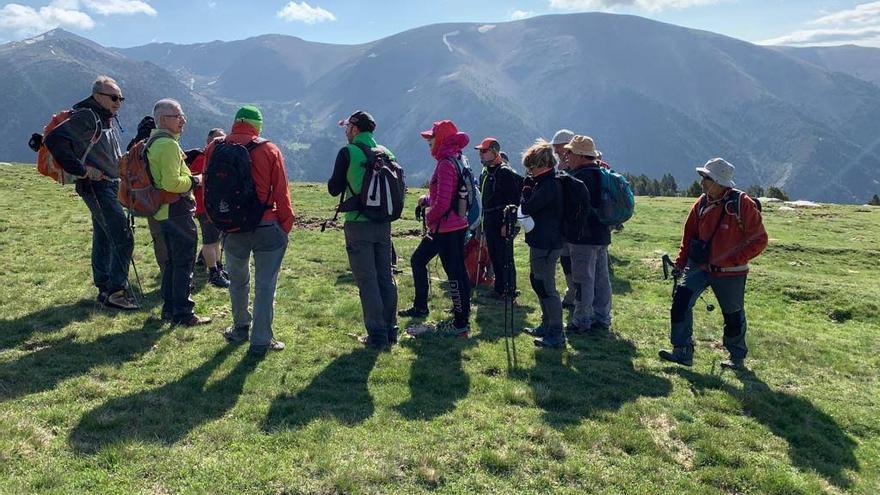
{"left": 45, "top": 76, "right": 138, "bottom": 309}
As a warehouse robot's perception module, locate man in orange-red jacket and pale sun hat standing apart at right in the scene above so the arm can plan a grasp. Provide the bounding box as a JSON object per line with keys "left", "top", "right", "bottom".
{"left": 660, "top": 158, "right": 767, "bottom": 369}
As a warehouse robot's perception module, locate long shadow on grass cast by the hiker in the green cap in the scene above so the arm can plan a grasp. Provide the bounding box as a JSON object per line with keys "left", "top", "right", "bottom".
{"left": 68, "top": 346, "right": 259, "bottom": 454}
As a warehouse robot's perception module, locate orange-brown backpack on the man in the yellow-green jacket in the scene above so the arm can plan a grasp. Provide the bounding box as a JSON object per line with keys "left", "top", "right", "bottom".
{"left": 118, "top": 134, "right": 180, "bottom": 217}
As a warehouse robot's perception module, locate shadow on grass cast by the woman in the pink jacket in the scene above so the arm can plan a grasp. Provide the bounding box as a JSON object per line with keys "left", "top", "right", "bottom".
{"left": 394, "top": 335, "right": 471, "bottom": 420}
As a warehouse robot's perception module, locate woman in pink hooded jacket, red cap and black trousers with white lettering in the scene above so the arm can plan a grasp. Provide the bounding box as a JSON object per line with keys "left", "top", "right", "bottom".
{"left": 398, "top": 120, "right": 471, "bottom": 337}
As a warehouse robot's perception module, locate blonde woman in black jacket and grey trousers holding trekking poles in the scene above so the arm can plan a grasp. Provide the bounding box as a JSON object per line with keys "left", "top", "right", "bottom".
{"left": 522, "top": 139, "right": 565, "bottom": 349}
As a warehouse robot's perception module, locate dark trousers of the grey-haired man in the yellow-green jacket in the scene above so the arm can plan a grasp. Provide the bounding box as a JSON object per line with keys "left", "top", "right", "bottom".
{"left": 159, "top": 215, "right": 198, "bottom": 323}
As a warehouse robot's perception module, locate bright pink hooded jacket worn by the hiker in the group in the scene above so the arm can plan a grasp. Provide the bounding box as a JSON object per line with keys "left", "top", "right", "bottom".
{"left": 424, "top": 132, "right": 470, "bottom": 233}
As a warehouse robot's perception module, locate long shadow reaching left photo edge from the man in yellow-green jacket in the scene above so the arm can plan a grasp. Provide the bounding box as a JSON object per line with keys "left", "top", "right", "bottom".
{"left": 0, "top": 318, "right": 163, "bottom": 402}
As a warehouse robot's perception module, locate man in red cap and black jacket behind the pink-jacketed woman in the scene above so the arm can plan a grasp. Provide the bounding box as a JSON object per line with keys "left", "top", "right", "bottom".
{"left": 474, "top": 137, "right": 523, "bottom": 299}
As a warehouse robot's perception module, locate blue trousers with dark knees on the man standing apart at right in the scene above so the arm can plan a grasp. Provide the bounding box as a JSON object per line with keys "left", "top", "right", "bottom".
{"left": 669, "top": 265, "right": 749, "bottom": 361}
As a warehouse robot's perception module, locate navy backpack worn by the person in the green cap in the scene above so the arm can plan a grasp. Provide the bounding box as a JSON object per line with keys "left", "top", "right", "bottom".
{"left": 204, "top": 138, "right": 272, "bottom": 232}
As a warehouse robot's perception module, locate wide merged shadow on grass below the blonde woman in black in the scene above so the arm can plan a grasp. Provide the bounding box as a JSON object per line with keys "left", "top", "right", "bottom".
{"left": 524, "top": 333, "right": 672, "bottom": 428}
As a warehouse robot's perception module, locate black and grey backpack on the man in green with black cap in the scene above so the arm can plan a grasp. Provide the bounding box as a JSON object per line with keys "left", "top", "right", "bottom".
{"left": 339, "top": 143, "right": 406, "bottom": 222}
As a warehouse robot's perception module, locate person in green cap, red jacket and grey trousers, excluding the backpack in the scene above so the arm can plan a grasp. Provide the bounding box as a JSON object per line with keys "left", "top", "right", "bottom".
{"left": 205, "top": 105, "right": 294, "bottom": 357}
